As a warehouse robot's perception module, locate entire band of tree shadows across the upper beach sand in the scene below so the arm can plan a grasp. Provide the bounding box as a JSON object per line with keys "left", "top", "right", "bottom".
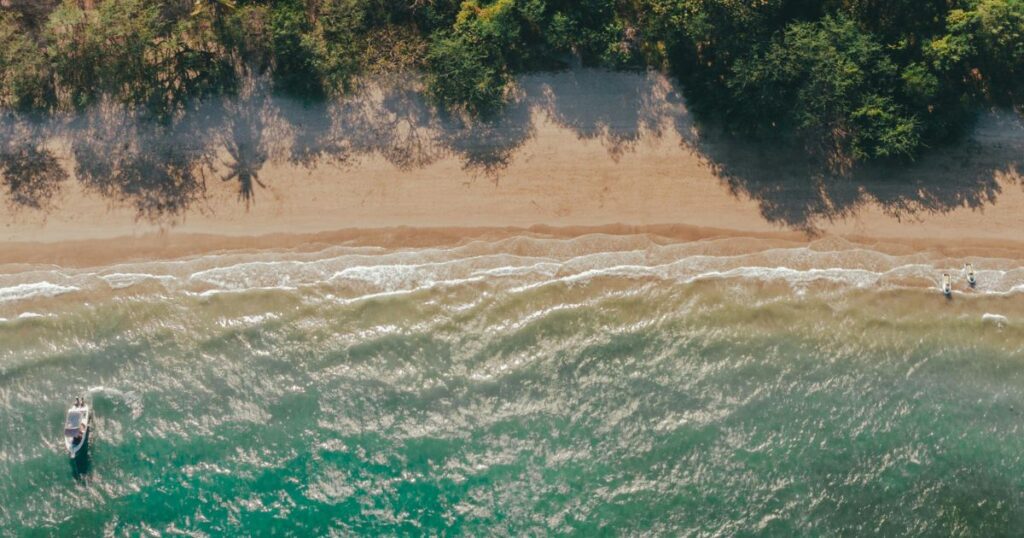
{"left": 0, "top": 70, "right": 1024, "bottom": 234}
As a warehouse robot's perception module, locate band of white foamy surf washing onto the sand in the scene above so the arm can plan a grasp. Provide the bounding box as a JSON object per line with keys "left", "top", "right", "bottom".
{"left": 9, "top": 235, "right": 1024, "bottom": 302}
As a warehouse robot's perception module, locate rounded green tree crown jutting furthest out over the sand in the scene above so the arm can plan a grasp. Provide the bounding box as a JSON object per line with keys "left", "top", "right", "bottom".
{"left": 726, "top": 17, "right": 920, "bottom": 168}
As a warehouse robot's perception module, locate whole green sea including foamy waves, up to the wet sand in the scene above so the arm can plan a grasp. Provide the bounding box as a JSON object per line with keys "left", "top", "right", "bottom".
{"left": 0, "top": 236, "right": 1024, "bottom": 536}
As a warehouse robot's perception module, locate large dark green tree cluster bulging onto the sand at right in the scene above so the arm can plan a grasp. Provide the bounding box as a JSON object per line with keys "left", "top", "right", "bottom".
{"left": 647, "top": 0, "right": 1024, "bottom": 169}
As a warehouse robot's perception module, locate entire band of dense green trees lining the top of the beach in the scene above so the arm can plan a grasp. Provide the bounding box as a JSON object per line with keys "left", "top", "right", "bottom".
{"left": 0, "top": 0, "right": 1024, "bottom": 169}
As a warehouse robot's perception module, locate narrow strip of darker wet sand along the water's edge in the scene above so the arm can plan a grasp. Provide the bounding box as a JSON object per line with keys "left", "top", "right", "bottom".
{"left": 0, "top": 224, "right": 1024, "bottom": 274}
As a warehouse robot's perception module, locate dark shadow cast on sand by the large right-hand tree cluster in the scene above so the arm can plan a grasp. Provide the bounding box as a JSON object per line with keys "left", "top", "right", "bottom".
{"left": 679, "top": 116, "right": 1024, "bottom": 235}
